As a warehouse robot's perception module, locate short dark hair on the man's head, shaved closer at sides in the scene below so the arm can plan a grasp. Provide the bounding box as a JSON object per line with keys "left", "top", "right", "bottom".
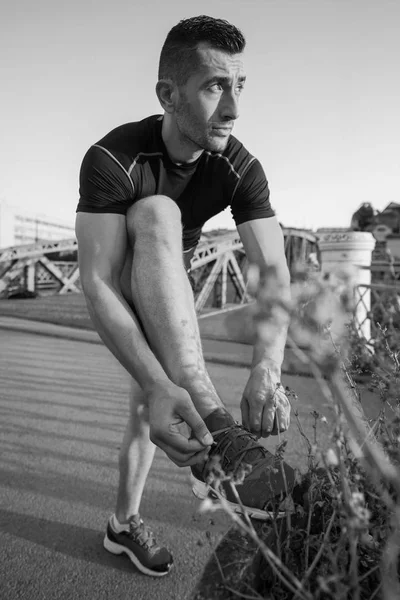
{"left": 158, "top": 15, "right": 246, "bottom": 85}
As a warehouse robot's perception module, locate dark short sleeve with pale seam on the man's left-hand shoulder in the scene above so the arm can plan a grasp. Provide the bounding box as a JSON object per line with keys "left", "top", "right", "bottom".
{"left": 76, "top": 146, "right": 134, "bottom": 215}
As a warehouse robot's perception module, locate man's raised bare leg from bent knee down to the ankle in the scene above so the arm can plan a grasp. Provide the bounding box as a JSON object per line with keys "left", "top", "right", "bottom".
{"left": 127, "top": 196, "right": 227, "bottom": 418}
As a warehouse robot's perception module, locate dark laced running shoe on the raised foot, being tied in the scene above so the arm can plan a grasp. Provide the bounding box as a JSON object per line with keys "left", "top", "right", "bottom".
{"left": 191, "top": 409, "right": 296, "bottom": 521}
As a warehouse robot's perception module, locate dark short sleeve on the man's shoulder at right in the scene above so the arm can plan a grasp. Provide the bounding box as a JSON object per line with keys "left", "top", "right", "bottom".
{"left": 231, "top": 158, "right": 275, "bottom": 225}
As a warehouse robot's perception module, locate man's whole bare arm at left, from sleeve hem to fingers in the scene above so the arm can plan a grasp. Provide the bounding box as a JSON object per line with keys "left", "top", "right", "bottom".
{"left": 76, "top": 212, "right": 213, "bottom": 466}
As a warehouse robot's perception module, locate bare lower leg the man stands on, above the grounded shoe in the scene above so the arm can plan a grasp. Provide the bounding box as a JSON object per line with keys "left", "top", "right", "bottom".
{"left": 115, "top": 380, "right": 155, "bottom": 523}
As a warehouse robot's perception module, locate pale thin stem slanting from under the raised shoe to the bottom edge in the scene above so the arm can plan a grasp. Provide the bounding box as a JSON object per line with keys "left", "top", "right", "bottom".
{"left": 214, "top": 488, "right": 312, "bottom": 600}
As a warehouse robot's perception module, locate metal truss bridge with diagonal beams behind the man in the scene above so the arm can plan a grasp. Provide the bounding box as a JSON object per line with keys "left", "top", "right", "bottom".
{"left": 0, "top": 229, "right": 317, "bottom": 313}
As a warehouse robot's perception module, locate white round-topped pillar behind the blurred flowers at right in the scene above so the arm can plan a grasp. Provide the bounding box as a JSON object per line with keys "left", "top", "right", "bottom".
{"left": 317, "top": 230, "right": 375, "bottom": 341}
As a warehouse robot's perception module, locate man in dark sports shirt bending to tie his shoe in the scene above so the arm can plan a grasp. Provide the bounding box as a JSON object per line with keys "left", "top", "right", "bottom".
{"left": 76, "top": 16, "right": 294, "bottom": 576}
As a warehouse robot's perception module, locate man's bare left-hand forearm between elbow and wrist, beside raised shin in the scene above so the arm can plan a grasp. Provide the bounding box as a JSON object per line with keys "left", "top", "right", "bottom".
{"left": 84, "top": 280, "right": 168, "bottom": 389}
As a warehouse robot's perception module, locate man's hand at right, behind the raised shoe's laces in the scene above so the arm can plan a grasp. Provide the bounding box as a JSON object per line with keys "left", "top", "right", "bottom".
{"left": 240, "top": 364, "right": 290, "bottom": 437}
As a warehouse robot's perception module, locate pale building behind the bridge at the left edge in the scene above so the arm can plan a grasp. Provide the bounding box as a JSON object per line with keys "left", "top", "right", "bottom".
{"left": 0, "top": 200, "right": 75, "bottom": 248}
